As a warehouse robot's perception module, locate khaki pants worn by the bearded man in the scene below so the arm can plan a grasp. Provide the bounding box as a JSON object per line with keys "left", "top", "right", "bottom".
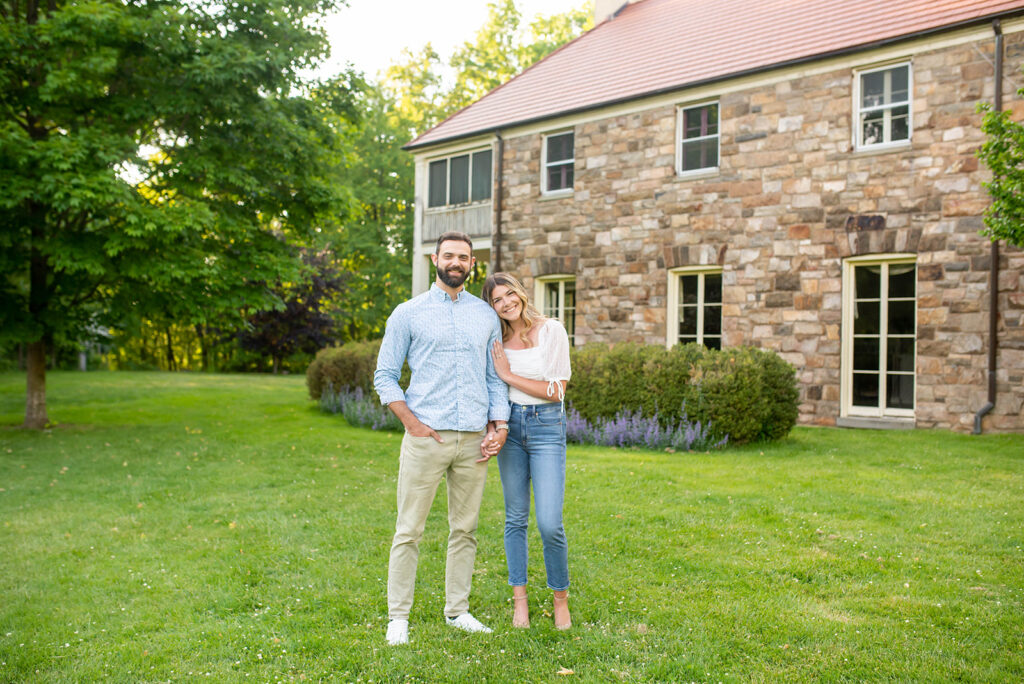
{"left": 387, "top": 430, "right": 487, "bottom": 619}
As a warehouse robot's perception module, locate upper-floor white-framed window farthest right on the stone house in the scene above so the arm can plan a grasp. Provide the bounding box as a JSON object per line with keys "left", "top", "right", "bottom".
{"left": 854, "top": 62, "right": 911, "bottom": 149}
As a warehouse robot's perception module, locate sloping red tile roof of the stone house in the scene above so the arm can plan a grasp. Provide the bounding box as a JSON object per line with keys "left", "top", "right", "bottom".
{"left": 407, "top": 0, "right": 1024, "bottom": 148}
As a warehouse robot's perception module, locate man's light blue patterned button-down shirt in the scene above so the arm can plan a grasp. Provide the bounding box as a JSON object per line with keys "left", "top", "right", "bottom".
{"left": 374, "top": 284, "right": 509, "bottom": 432}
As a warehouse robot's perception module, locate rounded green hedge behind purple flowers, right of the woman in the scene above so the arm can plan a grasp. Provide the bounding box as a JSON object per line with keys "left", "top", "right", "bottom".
{"left": 566, "top": 343, "right": 799, "bottom": 444}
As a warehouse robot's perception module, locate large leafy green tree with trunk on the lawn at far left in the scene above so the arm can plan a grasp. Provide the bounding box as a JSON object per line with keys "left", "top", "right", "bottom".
{"left": 0, "top": 0, "right": 351, "bottom": 428}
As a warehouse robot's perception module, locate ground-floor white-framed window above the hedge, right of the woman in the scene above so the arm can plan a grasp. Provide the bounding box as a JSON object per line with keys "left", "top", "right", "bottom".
{"left": 666, "top": 266, "right": 722, "bottom": 349}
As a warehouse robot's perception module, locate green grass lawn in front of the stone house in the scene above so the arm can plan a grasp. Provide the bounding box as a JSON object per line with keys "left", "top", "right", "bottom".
{"left": 0, "top": 373, "right": 1024, "bottom": 682}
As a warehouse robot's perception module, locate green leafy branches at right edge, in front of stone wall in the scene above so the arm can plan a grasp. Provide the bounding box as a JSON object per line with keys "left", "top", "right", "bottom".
{"left": 978, "top": 102, "right": 1024, "bottom": 247}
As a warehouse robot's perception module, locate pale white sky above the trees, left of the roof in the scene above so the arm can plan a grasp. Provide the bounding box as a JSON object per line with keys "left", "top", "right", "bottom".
{"left": 319, "top": 0, "right": 584, "bottom": 78}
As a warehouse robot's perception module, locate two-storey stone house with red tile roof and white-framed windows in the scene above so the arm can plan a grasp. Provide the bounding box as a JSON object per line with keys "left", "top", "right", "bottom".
{"left": 407, "top": 0, "right": 1024, "bottom": 430}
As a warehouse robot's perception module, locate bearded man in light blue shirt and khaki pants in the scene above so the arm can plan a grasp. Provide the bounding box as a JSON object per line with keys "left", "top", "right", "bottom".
{"left": 374, "top": 232, "right": 509, "bottom": 645}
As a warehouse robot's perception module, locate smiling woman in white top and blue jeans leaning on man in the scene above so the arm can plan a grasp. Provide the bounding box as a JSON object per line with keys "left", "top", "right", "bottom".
{"left": 481, "top": 273, "right": 572, "bottom": 630}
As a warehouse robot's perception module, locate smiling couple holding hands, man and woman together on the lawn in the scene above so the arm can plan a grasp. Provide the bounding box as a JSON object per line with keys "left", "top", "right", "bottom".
{"left": 374, "top": 232, "right": 571, "bottom": 645}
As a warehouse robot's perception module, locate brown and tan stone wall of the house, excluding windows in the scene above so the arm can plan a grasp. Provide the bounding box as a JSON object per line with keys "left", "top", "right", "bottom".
{"left": 495, "top": 33, "right": 1024, "bottom": 430}
